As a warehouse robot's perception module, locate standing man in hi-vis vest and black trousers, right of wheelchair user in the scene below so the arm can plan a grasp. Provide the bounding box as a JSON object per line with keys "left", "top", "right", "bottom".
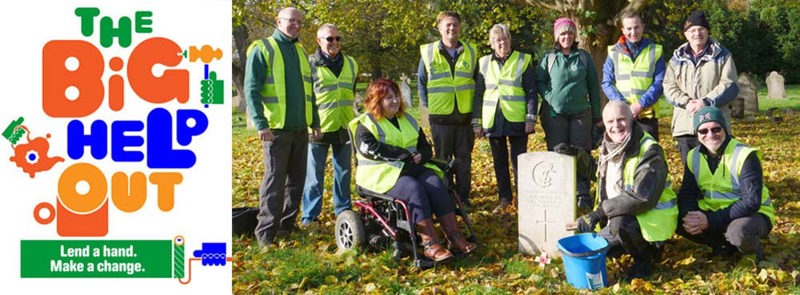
{"left": 417, "top": 11, "right": 478, "bottom": 204}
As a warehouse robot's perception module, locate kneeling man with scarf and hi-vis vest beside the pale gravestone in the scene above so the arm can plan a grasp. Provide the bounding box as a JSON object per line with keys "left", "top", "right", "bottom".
{"left": 576, "top": 101, "right": 678, "bottom": 280}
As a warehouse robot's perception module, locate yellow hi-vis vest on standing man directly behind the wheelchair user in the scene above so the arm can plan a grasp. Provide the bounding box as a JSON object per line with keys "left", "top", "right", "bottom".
{"left": 420, "top": 42, "right": 478, "bottom": 115}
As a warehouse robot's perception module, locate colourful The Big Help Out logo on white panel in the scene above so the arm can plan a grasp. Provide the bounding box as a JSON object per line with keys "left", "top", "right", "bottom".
{"left": 0, "top": 1, "right": 231, "bottom": 290}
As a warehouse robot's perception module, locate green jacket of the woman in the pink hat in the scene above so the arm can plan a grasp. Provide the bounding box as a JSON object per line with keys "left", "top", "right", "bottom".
{"left": 536, "top": 49, "right": 602, "bottom": 121}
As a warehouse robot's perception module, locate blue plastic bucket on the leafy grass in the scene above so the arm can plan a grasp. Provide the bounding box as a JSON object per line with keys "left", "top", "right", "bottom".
{"left": 558, "top": 233, "right": 608, "bottom": 289}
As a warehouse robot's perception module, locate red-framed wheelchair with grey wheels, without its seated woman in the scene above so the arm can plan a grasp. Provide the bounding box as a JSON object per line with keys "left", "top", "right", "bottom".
{"left": 335, "top": 159, "right": 478, "bottom": 269}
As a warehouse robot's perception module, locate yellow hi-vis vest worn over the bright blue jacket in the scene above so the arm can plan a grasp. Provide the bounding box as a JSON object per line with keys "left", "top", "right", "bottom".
{"left": 608, "top": 43, "right": 664, "bottom": 118}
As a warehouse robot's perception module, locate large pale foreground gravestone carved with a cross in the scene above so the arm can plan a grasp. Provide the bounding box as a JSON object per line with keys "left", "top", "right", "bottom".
{"left": 517, "top": 152, "right": 575, "bottom": 257}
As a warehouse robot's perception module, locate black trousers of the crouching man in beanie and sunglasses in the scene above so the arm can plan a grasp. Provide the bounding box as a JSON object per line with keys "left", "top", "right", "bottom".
{"left": 675, "top": 213, "right": 772, "bottom": 254}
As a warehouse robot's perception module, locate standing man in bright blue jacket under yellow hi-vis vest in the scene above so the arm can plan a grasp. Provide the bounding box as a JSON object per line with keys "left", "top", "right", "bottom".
{"left": 601, "top": 10, "right": 667, "bottom": 141}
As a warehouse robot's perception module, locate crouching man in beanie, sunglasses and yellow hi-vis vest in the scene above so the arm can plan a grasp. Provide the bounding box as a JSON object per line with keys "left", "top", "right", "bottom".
{"left": 676, "top": 106, "right": 775, "bottom": 267}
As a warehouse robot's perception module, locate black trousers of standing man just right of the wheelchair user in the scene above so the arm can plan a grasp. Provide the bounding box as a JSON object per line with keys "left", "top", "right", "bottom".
{"left": 431, "top": 124, "right": 475, "bottom": 200}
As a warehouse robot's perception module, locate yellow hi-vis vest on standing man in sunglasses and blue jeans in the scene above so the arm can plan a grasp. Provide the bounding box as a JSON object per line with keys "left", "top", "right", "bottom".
{"left": 308, "top": 55, "right": 358, "bottom": 132}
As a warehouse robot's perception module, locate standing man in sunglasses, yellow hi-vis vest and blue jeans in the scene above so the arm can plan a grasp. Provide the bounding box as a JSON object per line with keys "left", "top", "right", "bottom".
{"left": 301, "top": 23, "right": 358, "bottom": 228}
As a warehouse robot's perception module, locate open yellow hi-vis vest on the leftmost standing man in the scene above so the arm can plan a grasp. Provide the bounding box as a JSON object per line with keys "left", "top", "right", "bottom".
{"left": 247, "top": 37, "right": 313, "bottom": 129}
